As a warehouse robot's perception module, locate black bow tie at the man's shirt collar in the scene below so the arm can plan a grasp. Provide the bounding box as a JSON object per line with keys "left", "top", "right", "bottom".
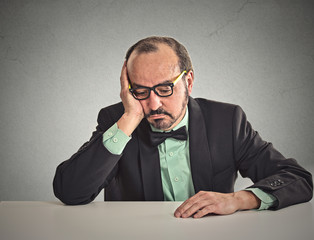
{"left": 150, "top": 126, "right": 188, "bottom": 147}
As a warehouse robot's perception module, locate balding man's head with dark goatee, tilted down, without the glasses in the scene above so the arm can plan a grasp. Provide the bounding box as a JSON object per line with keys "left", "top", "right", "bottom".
{"left": 126, "top": 37, "right": 194, "bottom": 130}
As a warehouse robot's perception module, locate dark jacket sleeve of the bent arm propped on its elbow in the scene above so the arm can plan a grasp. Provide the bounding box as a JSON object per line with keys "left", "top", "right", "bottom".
{"left": 53, "top": 103, "right": 122, "bottom": 205}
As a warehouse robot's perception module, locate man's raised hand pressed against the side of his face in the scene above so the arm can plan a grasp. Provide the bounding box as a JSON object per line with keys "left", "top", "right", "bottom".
{"left": 117, "top": 62, "right": 144, "bottom": 136}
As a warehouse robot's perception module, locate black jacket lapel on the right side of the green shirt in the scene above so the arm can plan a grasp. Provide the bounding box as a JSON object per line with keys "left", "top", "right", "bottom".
{"left": 188, "top": 97, "right": 213, "bottom": 193}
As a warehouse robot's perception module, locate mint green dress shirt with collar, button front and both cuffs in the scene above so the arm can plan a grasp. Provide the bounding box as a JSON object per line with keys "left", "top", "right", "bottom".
{"left": 103, "top": 109, "right": 276, "bottom": 210}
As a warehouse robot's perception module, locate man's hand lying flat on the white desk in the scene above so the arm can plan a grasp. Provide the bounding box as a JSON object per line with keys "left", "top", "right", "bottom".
{"left": 174, "top": 191, "right": 260, "bottom": 218}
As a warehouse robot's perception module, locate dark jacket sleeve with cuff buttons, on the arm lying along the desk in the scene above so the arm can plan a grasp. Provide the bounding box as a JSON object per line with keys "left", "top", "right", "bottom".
{"left": 233, "top": 106, "right": 313, "bottom": 209}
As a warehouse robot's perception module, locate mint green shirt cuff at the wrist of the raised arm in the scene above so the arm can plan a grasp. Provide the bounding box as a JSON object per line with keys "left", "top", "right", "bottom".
{"left": 102, "top": 123, "right": 131, "bottom": 155}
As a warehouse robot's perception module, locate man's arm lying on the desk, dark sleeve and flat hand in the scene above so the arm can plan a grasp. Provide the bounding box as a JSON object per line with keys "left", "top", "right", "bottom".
{"left": 175, "top": 104, "right": 313, "bottom": 217}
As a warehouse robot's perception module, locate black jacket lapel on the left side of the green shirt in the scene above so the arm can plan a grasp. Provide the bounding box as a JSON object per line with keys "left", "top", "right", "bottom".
{"left": 136, "top": 119, "right": 164, "bottom": 201}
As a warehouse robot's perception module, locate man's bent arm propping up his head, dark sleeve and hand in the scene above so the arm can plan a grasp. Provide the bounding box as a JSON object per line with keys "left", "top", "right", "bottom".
{"left": 53, "top": 63, "right": 144, "bottom": 205}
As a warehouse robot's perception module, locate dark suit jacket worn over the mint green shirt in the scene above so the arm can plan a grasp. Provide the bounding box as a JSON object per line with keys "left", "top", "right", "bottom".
{"left": 53, "top": 98, "right": 313, "bottom": 208}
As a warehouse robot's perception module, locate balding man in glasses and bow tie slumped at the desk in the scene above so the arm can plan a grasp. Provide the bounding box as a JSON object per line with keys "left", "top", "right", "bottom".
{"left": 53, "top": 37, "right": 313, "bottom": 218}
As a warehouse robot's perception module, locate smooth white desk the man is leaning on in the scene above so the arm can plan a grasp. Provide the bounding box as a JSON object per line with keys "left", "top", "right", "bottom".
{"left": 0, "top": 202, "right": 314, "bottom": 240}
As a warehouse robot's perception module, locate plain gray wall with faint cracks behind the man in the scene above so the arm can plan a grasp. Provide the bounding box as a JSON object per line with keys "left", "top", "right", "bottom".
{"left": 0, "top": 0, "right": 314, "bottom": 200}
